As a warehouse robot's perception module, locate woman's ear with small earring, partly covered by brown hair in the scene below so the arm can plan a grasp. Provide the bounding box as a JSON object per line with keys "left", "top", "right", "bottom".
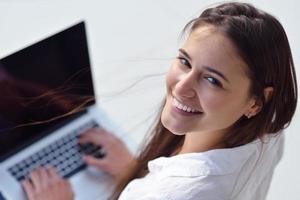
{"left": 245, "top": 87, "right": 274, "bottom": 118}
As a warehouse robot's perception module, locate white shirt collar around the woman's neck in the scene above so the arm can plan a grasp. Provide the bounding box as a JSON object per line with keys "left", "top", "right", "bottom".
{"left": 148, "top": 140, "right": 261, "bottom": 177}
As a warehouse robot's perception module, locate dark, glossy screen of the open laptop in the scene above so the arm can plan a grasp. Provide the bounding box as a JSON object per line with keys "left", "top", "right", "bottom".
{"left": 0, "top": 22, "right": 95, "bottom": 160}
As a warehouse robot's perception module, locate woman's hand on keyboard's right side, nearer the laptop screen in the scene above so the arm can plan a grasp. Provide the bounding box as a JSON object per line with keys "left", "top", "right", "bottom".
{"left": 79, "top": 128, "right": 135, "bottom": 176}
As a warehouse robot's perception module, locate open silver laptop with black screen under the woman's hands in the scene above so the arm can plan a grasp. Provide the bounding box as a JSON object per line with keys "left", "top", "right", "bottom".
{"left": 0, "top": 21, "right": 122, "bottom": 200}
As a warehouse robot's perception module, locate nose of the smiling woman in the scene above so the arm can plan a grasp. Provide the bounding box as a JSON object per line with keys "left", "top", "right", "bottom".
{"left": 174, "top": 71, "right": 197, "bottom": 98}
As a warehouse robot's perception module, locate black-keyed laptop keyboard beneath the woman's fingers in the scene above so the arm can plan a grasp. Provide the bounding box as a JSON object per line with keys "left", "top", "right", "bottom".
{"left": 8, "top": 121, "right": 105, "bottom": 181}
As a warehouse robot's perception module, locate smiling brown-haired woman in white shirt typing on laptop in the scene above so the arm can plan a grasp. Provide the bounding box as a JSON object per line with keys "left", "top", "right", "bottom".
{"left": 24, "top": 3, "right": 297, "bottom": 200}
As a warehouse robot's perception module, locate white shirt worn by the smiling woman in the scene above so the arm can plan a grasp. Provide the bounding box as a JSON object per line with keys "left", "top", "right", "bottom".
{"left": 119, "top": 133, "right": 284, "bottom": 200}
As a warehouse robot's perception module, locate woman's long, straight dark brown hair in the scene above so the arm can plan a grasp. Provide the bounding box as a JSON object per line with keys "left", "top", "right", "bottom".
{"left": 112, "top": 2, "right": 298, "bottom": 199}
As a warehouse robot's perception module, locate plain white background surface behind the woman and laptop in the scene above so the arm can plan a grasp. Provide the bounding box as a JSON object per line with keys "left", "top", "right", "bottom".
{"left": 0, "top": 0, "right": 300, "bottom": 200}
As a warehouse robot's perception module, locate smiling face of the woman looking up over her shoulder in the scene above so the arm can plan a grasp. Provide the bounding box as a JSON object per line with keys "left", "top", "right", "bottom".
{"left": 161, "top": 26, "right": 255, "bottom": 135}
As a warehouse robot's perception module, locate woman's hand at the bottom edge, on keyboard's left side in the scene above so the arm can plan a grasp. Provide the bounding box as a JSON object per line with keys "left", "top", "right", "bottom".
{"left": 22, "top": 167, "right": 74, "bottom": 200}
